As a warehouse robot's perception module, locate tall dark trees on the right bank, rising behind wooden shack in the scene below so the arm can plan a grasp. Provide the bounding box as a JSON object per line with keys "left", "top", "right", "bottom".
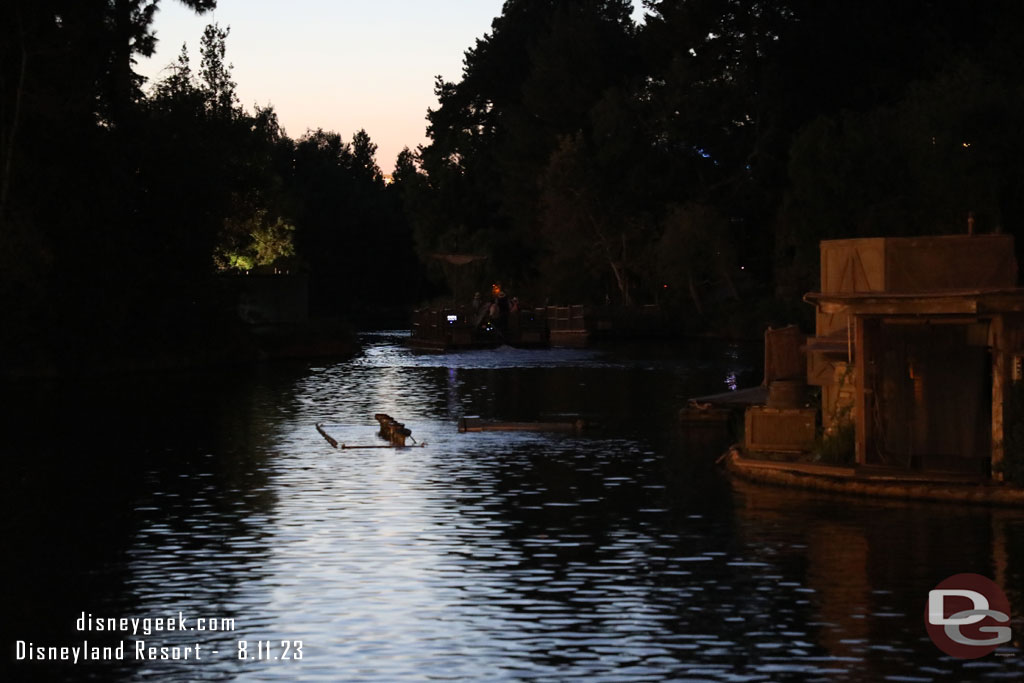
{"left": 410, "top": 0, "right": 1024, "bottom": 323}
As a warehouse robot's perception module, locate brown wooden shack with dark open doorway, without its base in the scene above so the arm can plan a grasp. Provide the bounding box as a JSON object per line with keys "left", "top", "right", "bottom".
{"left": 805, "top": 234, "right": 1024, "bottom": 477}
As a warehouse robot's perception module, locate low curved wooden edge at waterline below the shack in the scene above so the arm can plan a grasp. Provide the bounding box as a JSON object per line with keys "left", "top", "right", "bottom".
{"left": 724, "top": 449, "right": 1024, "bottom": 507}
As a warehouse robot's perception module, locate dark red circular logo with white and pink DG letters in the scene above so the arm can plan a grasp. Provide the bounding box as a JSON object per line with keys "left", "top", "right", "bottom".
{"left": 925, "top": 573, "right": 1012, "bottom": 659}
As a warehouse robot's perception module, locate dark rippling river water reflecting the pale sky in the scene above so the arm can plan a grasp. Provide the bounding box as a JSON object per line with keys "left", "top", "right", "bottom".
{"left": 3, "top": 333, "right": 1024, "bottom": 681}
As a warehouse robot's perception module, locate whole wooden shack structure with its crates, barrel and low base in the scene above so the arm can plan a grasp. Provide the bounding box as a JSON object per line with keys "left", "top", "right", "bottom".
{"left": 680, "top": 232, "right": 1024, "bottom": 506}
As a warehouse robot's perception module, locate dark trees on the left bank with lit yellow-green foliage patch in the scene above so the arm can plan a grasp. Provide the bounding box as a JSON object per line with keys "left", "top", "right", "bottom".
{"left": 0, "top": 0, "right": 422, "bottom": 374}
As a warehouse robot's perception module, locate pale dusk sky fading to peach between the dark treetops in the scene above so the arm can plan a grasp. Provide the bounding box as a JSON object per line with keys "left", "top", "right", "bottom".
{"left": 136, "top": 0, "right": 503, "bottom": 173}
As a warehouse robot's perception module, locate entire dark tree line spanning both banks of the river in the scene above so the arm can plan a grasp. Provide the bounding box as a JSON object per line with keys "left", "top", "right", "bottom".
{"left": 0, "top": 0, "right": 1024, "bottom": 374}
